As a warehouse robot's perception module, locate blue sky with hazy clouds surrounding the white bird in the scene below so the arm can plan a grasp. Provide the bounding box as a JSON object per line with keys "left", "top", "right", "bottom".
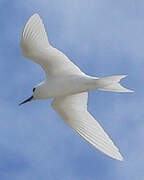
{"left": 0, "top": 0, "right": 144, "bottom": 180}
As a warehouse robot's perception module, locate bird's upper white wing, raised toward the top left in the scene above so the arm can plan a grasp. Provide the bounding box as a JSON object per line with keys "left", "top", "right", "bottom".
{"left": 21, "top": 14, "right": 83, "bottom": 76}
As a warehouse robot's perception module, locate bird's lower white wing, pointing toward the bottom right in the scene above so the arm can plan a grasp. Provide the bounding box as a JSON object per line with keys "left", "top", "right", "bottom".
{"left": 52, "top": 93, "right": 123, "bottom": 160}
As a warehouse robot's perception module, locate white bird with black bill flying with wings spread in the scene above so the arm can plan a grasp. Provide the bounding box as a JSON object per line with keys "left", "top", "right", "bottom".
{"left": 19, "top": 13, "right": 133, "bottom": 161}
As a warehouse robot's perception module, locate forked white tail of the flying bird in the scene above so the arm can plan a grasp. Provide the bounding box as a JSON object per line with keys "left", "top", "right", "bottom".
{"left": 97, "top": 75, "right": 133, "bottom": 92}
